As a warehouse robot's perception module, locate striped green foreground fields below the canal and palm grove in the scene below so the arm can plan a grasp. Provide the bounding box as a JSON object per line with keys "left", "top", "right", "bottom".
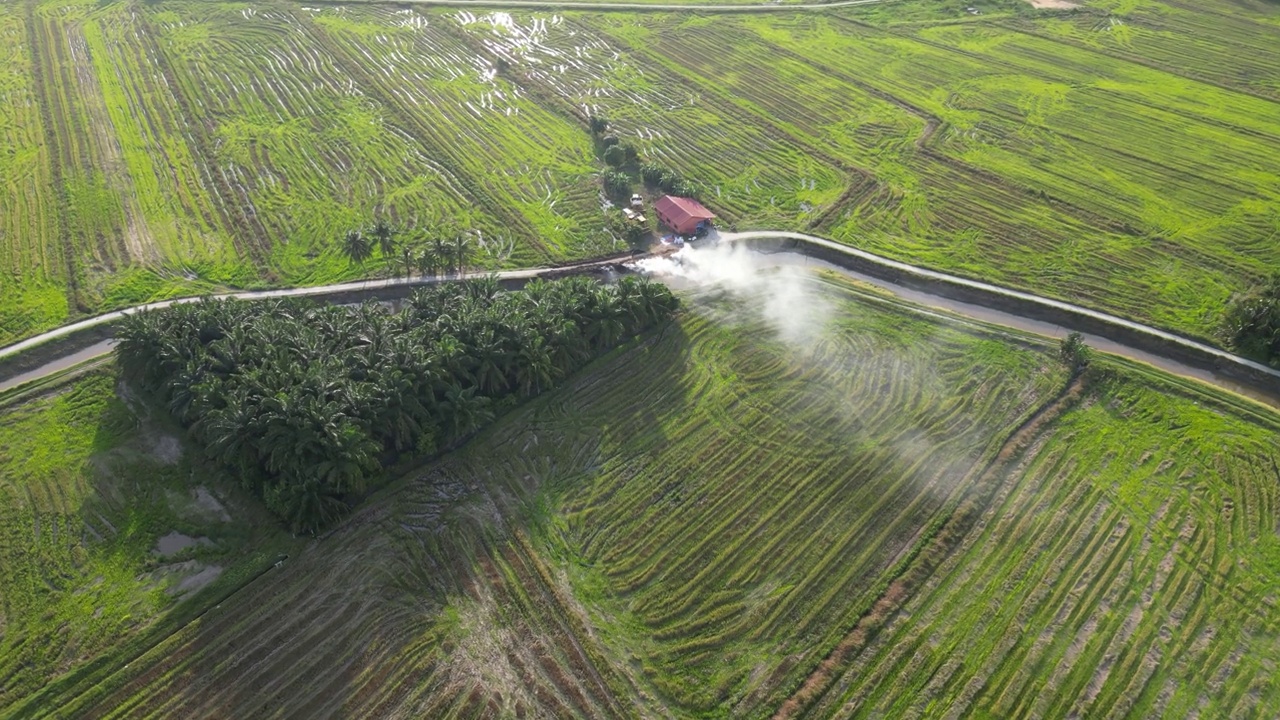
{"left": 0, "top": 275, "right": 1280, "bottom": 717}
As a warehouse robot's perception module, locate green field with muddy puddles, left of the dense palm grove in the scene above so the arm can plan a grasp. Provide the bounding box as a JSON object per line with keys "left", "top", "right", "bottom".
{"left": 0, "top": 370, "right": 294, "bottom": 714}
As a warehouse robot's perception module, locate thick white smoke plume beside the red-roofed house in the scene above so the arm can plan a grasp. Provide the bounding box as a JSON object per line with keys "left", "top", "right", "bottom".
{"left": 635, "top": 243, "right": 832, "bottom": 346}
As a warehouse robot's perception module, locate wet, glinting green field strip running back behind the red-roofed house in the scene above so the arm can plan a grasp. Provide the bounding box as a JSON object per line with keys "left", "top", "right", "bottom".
{"left": 448, "top": 13, "right": 849, "bottom": 227}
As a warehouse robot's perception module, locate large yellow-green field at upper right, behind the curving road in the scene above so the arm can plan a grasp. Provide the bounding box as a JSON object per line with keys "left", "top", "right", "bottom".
{"left": 596, "top": 10, "right": 1280, "bottom": 336}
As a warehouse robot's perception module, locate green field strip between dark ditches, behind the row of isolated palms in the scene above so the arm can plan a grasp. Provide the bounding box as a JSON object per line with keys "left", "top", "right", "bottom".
{"left": 147, "top": 3, "right": 529, "bottom": 271}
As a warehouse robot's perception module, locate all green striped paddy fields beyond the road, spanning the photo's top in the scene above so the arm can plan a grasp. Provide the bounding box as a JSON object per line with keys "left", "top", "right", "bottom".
{"left": 0, "top": 0, "right": 1280, "bottom": 342}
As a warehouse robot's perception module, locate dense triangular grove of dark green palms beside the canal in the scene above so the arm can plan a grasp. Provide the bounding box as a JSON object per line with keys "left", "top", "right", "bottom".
{"left": 118, "top": 275, "right": 677, "bottom": 532}
